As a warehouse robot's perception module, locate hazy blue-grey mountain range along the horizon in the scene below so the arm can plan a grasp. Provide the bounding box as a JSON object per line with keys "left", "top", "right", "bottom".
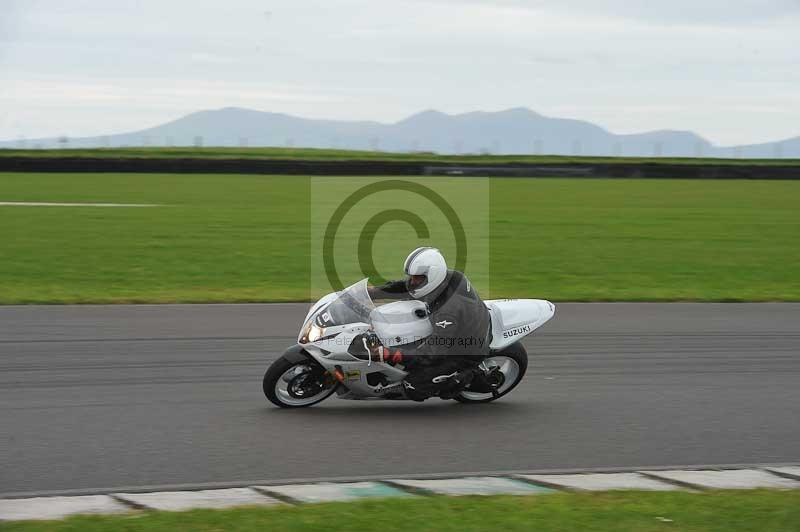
{"left": 0, "top": 107, "right": 800, "bottom": 158}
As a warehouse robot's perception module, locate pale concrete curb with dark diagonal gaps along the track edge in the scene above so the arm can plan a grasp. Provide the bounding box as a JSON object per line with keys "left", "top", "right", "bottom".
{"left": 0, "top": 465, "right": 800, "bottom": 521}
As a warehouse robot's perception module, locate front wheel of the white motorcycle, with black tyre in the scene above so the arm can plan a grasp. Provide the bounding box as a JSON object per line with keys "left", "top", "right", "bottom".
{"left": 263, "top": 357, "right": 338, "bottom": 408}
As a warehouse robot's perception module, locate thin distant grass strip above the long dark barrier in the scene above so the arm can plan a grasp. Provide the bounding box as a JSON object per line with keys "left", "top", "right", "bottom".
{"left": 0, "top": 146, "right": 800, "bottom": 166}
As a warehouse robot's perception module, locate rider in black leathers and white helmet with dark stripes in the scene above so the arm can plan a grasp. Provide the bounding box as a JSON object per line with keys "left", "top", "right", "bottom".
{"left": 370, "top": 247, "right": 491, "bottom": 401}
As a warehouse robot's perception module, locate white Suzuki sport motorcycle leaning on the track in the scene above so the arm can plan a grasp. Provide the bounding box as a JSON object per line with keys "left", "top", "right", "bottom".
{"left": 263, "top": 279, "right": 555, "bottom": 408}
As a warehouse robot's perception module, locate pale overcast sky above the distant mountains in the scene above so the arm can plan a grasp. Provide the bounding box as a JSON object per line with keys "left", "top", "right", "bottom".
{"left": 0, "top": 0, "right": 800, "bottom": 145}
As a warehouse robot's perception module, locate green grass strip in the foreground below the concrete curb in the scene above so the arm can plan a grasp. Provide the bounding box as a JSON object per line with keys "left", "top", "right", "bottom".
{"left": 2, "top": 490, "right": 800, "bottom": 532}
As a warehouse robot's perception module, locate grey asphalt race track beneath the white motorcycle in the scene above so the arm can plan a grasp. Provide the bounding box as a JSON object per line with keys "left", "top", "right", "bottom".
{"left": 0, "top": 303, "right": 800, "bottom": 495}
